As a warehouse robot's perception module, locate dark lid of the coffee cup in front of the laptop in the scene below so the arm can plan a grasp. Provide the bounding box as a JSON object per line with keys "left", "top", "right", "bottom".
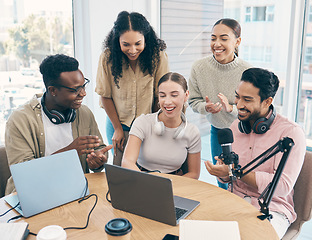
{"left": 105, "top": 218, "right": 132, "bottom": 236}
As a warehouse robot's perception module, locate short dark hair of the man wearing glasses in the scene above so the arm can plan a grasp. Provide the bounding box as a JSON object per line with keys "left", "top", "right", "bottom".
{"left": 40, "top": 54, "right": 79, "bottom": 89}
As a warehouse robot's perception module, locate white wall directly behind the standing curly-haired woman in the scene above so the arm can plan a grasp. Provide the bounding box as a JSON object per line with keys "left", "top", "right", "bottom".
{"left": 73, "top": 0, "right": 160, "bottom": 142}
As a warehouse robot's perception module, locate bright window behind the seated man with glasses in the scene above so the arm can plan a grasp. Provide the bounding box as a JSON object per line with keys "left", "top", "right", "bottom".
{"left": 0, "top": 0, "right": 74, "bottom": 144}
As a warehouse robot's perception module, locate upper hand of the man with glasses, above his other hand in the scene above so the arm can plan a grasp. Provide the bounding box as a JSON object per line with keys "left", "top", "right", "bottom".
{"left": 66, "top": 136, "right": 101, "bottom": 156}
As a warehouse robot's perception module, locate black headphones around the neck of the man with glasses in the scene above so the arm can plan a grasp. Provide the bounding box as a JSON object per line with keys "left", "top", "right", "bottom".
{"left": 41, "top": 93, "right": 76, "bottom": 124}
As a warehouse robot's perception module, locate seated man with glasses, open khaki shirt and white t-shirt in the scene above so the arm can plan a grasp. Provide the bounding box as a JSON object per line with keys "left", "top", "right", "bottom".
{"left": 5, "top": 54, "right": 112, "bottom": 194}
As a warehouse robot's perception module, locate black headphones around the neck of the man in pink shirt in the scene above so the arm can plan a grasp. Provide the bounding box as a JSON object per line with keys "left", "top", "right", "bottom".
{"left": 238, "top": 104, "right": 276, "bottom": 134}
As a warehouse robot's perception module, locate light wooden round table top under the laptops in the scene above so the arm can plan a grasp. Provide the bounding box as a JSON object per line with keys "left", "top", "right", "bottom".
{"left": 0, "top": 173, "right": 278, "bottom": 240}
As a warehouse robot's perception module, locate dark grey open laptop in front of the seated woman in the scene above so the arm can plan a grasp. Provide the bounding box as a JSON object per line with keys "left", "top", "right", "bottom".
{"left": 105, "top": 164, "right": 199, "bottom": 226}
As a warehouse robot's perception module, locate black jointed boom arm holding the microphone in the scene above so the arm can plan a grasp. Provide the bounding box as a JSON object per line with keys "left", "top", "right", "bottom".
{"left": 225, "top": 137, "right": 294, "bottom": 220}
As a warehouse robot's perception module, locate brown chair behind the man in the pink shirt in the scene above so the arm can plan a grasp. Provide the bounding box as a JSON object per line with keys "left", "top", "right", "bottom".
{"left": 282, "top": 151, "right": 312, "bottom": 240}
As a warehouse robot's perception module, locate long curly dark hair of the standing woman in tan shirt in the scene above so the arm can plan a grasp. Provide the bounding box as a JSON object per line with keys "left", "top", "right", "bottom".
{"left": 103, "top": 11, "right": 166, "bottom": 88}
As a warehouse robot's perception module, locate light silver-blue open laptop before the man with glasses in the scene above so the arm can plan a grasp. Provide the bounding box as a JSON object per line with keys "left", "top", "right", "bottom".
{"left": 5, "top": 150, "right": 89, "bottom": 217}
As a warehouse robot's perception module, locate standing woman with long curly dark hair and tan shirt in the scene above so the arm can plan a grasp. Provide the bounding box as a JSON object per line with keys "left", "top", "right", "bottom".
{"left": 95, "top": 11, "right": 169, "bottom": 165}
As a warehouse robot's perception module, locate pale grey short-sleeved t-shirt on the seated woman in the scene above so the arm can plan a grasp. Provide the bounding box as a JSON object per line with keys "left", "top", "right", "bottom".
{"left": 129, "top": 113, "right": 201, "bottom": 173}
